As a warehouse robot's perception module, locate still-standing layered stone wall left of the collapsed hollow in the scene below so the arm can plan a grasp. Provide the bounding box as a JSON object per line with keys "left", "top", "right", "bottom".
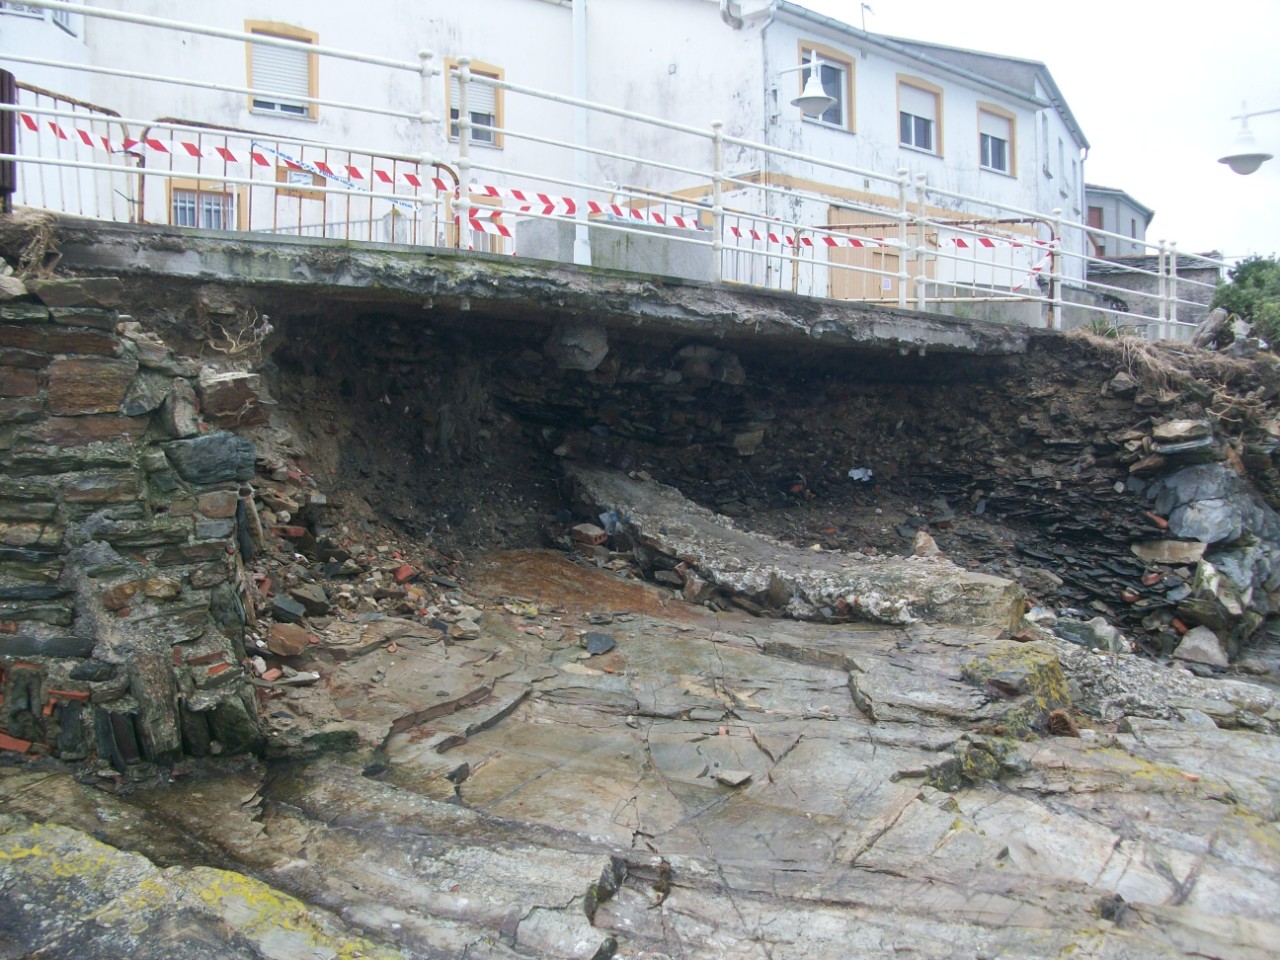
{"left": 0, "top": 276, "right": 262, "bottom": 769}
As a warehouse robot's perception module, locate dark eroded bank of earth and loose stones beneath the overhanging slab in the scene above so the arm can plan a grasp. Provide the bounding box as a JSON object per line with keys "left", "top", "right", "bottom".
{"left": 274, "top": 312, "right": 1280, "bottom": 660}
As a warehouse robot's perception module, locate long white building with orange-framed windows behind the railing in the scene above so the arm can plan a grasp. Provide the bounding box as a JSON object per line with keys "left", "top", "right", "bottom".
{"left": 0, "top": 0, "right": 1088, "bottom": 300}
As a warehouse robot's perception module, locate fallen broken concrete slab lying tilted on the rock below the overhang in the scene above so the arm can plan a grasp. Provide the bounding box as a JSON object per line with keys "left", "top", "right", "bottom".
{"left": 567, "top": 465, "right": 1025, "bottom": 640}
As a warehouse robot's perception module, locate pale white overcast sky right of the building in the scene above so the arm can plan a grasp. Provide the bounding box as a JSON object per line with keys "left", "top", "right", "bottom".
{"left": 799, "top": 0, "right": 1280, "bottom": 257}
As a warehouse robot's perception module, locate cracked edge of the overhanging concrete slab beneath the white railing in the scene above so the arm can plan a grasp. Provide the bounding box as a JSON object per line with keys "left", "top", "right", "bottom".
{"left": 20, "top": 218, "right": 1032, "bottom": 355}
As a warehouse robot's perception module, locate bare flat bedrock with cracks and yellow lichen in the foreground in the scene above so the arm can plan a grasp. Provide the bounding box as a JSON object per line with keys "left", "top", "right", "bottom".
{"left": 0, "top": 552, "right": 1280, "bottom": 960}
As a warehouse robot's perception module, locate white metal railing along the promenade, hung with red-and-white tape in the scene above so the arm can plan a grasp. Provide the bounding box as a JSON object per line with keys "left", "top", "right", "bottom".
{"left": 0, "top": 0, "right": 1224, "bottom": 338}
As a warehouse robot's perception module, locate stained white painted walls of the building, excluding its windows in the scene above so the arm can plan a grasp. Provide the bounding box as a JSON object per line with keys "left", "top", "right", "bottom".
{"left": 0, "top": 0, "right": 1083, "bottom": 293}
